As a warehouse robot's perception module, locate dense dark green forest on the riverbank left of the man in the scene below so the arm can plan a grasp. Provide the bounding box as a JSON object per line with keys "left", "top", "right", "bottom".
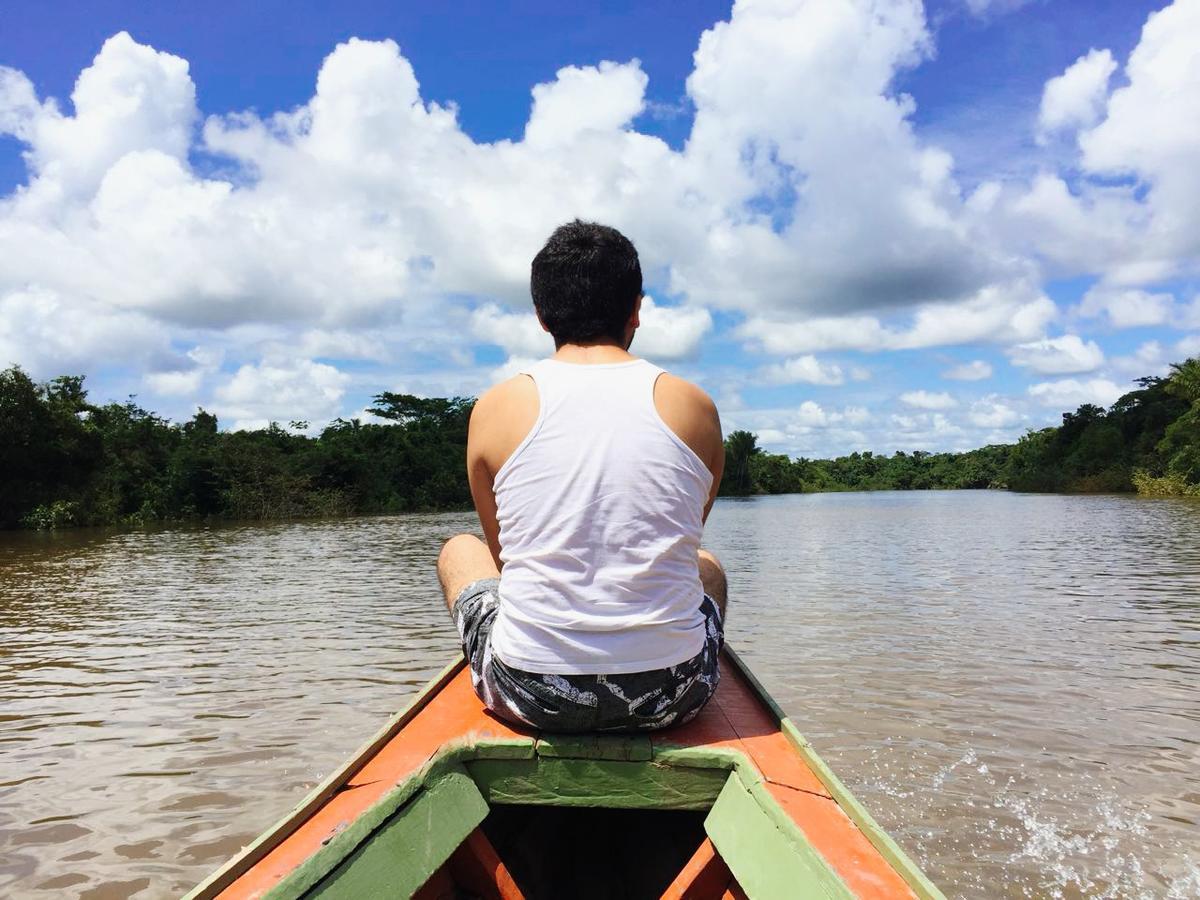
{"left": 0, "top": 368, "right": 473, "bottom": 528}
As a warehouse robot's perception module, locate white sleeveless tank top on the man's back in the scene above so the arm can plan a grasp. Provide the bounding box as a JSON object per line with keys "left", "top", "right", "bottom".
{"left": 492, "top": 359, "right": 713, "bottom": 674}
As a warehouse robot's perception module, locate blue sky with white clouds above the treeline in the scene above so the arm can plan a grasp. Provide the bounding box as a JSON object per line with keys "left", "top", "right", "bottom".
{"left": 0, "top": 0, "right": 1200, "bottom": 457}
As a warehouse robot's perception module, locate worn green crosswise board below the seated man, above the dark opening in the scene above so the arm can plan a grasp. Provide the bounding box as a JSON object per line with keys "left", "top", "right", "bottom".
{"left": 467, "top": 757, "right": 726, "bottom": 810}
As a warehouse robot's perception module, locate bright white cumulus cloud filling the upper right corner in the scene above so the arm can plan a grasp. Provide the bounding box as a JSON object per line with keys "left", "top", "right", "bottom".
{"left": 990, "top": 0, "right": 1200, "bottom": 287}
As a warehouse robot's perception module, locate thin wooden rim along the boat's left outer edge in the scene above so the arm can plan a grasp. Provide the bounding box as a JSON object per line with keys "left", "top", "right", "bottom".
{"left": 185, "top": 656, "right": 466, "bottom": 900}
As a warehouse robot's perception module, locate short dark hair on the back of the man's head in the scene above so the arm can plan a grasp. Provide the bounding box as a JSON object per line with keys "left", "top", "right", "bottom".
{"left": 529, "top": 218, "right": 642, "bottom": 347}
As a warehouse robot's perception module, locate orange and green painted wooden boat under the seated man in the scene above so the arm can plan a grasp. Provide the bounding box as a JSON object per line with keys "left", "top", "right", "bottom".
{"left": 188, "top": 649, "right": 942, "bottom": 900}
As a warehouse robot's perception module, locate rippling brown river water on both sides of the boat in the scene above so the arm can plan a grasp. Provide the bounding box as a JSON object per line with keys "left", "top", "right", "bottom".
{"left": 0, "top": 492, "right": 1200, "bottom": 898}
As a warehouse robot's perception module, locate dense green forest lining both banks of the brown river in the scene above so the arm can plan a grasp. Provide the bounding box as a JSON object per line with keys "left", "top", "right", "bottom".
{"left": 0, "top": 359, "right": 1200, "bottom": 528}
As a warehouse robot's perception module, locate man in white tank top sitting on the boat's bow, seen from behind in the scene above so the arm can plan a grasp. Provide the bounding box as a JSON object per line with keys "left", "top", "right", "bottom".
{"left": 438, "top": 221, "right": 726, "bottom": 731}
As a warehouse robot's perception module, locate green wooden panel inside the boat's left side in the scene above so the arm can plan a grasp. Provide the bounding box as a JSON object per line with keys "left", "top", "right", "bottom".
{"left": 304, "top": 772, "right": 487, "bottom": 900}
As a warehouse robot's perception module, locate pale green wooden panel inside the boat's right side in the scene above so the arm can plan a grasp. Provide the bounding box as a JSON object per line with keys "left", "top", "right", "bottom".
{"left": 704, "top": 774, "right": 853, "bottom": 900}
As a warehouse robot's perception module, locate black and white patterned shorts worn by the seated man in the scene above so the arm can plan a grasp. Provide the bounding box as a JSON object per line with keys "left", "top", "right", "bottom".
{"left": 452, "top": 578, "right": 724, "bottom": 732}
